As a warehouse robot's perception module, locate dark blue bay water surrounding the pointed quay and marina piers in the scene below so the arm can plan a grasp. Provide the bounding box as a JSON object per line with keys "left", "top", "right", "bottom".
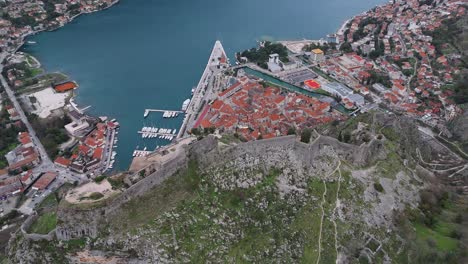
{"left": 23, "top": 0, "right": 385, "bottom": 170}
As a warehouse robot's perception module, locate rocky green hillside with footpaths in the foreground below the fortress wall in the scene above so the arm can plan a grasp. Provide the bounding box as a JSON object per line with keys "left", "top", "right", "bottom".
{"left": 5, "top": 114, "right": 467, "bottom": 263}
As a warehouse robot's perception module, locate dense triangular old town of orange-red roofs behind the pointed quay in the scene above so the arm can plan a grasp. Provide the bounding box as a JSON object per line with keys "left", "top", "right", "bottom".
{"left": 195, "top": 77, "right": 345, "bottom": 140}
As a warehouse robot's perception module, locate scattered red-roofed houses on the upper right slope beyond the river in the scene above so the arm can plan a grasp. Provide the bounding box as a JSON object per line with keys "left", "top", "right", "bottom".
{"left": 332, "top": 0, "right": 466, "bottom": 125}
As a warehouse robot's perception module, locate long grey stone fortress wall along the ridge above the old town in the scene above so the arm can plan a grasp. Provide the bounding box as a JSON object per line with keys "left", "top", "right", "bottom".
{"left": 55, "top": 136, "right": 383, "bottom": 240}
